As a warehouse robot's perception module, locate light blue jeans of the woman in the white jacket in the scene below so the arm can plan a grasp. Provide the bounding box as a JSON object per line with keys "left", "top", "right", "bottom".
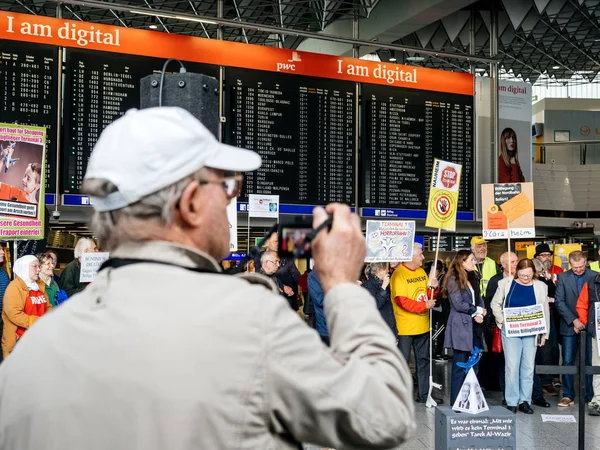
{"left": 502, "top": 327, "right": 537, "bottom": 406}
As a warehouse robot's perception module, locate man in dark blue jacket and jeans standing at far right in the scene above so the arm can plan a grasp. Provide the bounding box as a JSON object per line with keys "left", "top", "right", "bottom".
{"left": 554, "top": 250, "right": 596, "bottom": 407}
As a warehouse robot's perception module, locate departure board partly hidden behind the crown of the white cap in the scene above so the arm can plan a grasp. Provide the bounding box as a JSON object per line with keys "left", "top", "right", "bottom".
{"left": 62, "top": 49, "right": 218, "bottom": 194}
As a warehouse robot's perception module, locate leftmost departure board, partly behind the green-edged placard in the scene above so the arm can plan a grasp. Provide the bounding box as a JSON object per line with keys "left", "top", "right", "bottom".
{"left": 0, "top": 40, "right": 58, "bottom": 193}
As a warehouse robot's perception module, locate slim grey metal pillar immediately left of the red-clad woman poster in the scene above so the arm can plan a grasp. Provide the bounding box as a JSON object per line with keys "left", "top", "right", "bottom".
{"left": 490, "top": 2, "right": 500, "bottom": 183}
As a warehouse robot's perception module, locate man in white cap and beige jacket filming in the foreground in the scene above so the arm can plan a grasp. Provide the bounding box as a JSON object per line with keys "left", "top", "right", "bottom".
{"left": 0, "top": 108, "right": 415, "bottom": 450}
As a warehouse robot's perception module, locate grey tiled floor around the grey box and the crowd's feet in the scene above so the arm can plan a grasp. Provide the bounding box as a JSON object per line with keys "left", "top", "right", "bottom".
{"left": 305, "top": 362, "right": 600, "bottom": 450}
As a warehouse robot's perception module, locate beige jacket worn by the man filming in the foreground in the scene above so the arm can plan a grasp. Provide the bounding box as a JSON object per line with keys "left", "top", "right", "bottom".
{"left": 0, "top": 242, "right": 416, "bottom": 450}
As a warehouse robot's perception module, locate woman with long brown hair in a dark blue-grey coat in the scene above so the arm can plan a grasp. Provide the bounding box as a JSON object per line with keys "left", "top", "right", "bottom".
{"left": 441, "top": 250, "right": 486, "bottom": 405}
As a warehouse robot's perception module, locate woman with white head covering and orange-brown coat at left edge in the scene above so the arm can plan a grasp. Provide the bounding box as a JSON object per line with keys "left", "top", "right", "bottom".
{"left": 2, "top": 255, "right": 52, "bottom": 359}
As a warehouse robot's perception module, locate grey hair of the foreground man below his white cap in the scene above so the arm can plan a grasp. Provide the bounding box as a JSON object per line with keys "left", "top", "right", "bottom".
{"left": 81, "top": 170, "right": 204, "bottom": 250}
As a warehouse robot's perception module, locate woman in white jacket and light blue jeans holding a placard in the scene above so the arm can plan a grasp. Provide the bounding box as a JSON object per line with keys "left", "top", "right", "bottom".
{"left": 491, "top": 258, "right": 550, "bottom": 414}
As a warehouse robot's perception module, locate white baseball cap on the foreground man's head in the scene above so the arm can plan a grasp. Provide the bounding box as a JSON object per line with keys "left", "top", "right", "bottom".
{"left": 85, "top": 107, "right": 261, "bottom": 212}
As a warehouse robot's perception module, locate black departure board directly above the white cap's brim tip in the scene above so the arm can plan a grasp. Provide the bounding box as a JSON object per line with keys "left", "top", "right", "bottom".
{"left": 225, "top": 68, "right": 356, "bottom": 205}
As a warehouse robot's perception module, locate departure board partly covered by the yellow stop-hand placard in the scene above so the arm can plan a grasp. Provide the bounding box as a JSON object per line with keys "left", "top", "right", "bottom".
{"left": 361, "top": 84, "right": 474, "bottom": 211}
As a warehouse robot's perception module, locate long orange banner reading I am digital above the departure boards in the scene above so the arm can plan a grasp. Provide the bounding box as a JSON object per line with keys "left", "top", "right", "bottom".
{"left": 0, "top": 11, "right": 474, "bottom": 95}
